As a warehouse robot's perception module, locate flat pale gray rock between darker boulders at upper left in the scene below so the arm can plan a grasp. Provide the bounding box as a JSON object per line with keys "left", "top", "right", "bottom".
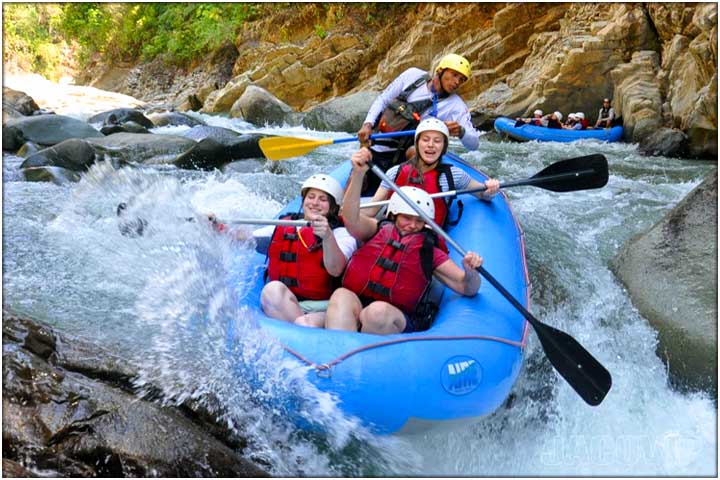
{"left": 88, "top": 133, "right": 196, "bottom": 164}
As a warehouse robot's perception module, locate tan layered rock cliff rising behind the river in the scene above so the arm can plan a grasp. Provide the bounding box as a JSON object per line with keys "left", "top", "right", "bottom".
{"left": 94, "top": 3, "right": 717, "bottom": 158}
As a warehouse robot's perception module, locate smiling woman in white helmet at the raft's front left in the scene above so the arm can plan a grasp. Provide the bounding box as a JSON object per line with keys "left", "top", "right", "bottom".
{"left": 214, "top": 174, "right": 357, "bottom": 327}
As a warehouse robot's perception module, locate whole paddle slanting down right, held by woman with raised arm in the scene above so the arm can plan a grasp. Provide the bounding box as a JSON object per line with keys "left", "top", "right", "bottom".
{"left": 368, "top": 162, "right": 612, "bottom": 405}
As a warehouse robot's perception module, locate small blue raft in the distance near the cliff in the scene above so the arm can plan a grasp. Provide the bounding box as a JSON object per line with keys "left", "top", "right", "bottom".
{"left": 495, "top": 117, "right": 623, "bottom": 142}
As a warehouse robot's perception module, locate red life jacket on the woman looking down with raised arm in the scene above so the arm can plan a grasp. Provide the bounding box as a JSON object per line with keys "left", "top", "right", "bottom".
{"left": 342, "top": 222, "right": 437, "bottom": 314}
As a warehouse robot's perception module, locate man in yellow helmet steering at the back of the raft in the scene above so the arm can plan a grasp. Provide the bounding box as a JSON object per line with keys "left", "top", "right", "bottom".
{"left": 357, "top": 53, "right": 480, "bottom": 196}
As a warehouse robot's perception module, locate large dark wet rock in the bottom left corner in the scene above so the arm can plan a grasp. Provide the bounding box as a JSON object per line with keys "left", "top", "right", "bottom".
{"left": 2, "top": 311, "right": 266, "bottom": 477}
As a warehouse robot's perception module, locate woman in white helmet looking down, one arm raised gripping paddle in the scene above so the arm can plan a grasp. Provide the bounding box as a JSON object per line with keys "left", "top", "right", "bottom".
{"left": 325, "top": 151, "right": 482, "bottom": 335}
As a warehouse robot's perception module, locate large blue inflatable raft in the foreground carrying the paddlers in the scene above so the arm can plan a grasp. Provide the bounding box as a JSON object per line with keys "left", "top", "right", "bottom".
{"left": 231, "top": 153, "right": 530, "bottom": 433}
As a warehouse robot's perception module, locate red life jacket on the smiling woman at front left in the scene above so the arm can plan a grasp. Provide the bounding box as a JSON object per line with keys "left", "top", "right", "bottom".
{"left": 267, "top": 214, "right": 335, "bottom": 300}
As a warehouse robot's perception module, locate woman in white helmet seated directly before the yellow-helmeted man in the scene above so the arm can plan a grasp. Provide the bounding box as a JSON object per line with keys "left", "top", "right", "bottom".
{"left": 357, "top": 117, "right": 500, "bottom": 232}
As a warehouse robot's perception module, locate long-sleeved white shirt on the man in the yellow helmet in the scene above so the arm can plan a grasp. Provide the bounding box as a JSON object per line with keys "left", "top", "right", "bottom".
{"left": 365, "top": 67, "right": 480, "bottom": 151}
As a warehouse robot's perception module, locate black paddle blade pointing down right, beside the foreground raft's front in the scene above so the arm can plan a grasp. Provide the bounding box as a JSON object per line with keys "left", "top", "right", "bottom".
{"left": 530, "top": 320, "right": 612, "bottom": 406}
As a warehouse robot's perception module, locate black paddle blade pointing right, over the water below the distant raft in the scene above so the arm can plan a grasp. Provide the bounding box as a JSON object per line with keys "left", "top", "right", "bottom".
{"left": 527, "top": 153, "right": 608, "bottom": 192}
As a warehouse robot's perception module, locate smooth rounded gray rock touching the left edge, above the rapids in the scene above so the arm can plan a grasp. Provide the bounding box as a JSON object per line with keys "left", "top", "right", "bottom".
{"left": 2, "top": 115, "right": 103, "bottom": 151}
